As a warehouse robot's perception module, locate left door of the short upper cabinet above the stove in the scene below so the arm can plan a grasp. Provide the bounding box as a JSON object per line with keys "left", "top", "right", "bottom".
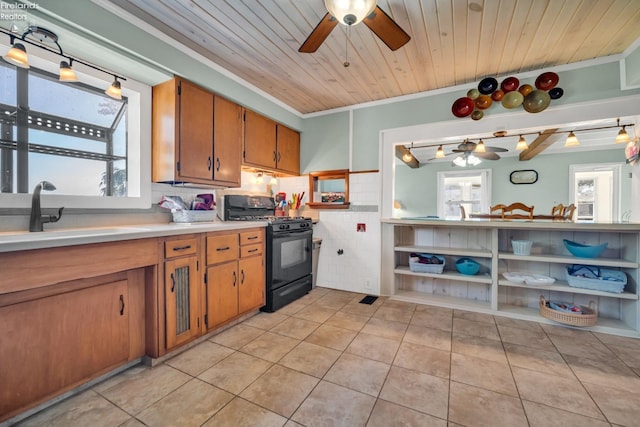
{"left": 244, "top": 110, "right": 277, "bottom": 169}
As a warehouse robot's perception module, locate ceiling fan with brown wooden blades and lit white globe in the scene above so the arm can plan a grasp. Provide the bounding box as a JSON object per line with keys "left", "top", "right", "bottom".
{"left": 298, "top": 0, "right": 411, "bottom": 53}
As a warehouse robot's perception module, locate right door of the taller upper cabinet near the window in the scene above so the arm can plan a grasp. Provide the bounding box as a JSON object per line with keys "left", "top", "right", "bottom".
{"left": 213, "top": 96, "right": 242, "bottom": 187}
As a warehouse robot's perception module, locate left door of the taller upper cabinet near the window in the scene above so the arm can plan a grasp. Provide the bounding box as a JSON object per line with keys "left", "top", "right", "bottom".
{"left": 178, "top": 80, "right": 213, "bottom": 181}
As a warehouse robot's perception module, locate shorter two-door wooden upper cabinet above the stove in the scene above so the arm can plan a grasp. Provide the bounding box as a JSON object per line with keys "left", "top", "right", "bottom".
{"left": 242, "top": 110, "right": 300, "bottom": 175}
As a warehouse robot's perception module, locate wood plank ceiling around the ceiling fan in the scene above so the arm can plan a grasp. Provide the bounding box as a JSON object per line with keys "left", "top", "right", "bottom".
{"left": 110, "top": 0, "right": 640, "bottom": 113}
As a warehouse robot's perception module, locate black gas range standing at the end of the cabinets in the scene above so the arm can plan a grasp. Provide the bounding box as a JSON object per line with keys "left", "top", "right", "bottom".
{"left": 218, "top": 195, "right": 313, "bottom": 312}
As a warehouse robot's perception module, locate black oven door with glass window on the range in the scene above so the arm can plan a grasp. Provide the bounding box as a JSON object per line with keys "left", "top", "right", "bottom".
{"left": 271, "top": 230, "right": 313, "bottom": 289}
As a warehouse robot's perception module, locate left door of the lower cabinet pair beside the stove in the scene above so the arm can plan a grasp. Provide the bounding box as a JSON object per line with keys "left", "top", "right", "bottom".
{"left": 207, "top": 261, "right": 238, "bottom": 329}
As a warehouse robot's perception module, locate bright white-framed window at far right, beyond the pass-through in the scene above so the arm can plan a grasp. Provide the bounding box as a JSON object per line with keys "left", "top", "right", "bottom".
{"left": 569, "top": 164, "right": 622, "bottom": 222}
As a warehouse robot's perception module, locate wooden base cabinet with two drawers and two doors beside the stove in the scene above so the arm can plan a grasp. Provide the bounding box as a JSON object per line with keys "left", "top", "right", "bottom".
{"left": 205, "top": 228, "right": 265, "bottom": 329}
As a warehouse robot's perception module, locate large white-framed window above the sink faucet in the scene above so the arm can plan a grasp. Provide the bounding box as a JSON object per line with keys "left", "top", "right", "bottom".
{"left": 0, "top": 44, "right": 151, "bottom": 208}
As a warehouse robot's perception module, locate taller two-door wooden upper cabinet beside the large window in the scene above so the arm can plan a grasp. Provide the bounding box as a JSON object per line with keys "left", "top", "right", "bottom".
{"left": 152, "top": 77, "right": 243, "bottom": 187}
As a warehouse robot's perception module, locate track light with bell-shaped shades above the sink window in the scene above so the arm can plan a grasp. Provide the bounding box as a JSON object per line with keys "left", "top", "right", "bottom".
{"left": 0, "top": 25, "right": 127, "bottom": 99}
